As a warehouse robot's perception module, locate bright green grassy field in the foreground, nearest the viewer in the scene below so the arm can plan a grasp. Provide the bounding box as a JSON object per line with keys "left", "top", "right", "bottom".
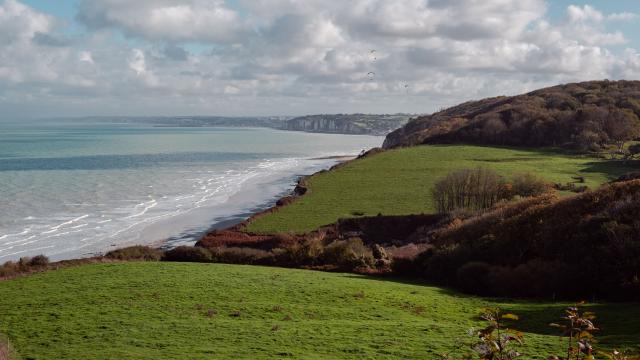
{"left": 0, "top": 263, "right": 640, "bottom": 359}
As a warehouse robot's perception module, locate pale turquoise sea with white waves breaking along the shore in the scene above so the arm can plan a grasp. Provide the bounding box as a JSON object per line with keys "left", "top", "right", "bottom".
{"left": 0, "top": 120, "right": 383, "bottom": 263}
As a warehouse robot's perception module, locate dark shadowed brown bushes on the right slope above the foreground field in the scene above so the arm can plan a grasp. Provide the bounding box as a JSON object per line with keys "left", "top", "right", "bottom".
{"left": 405, "top": 180, "right": 640, "bottom": 300}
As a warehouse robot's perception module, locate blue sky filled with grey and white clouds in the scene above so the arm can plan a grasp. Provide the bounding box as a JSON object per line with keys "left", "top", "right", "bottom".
{"left": 0, "top": 0, "right": 640, "bottom": 118}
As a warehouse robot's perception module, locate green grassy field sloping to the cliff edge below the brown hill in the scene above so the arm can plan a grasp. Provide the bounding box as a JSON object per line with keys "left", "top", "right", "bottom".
{"left": 247, "top": 145, "right": 630, "bottom": 233}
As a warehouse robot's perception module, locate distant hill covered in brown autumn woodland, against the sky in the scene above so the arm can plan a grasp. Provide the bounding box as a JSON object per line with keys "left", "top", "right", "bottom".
{"left": 383, "top": 81, "right": 640, "bottom": 151}
